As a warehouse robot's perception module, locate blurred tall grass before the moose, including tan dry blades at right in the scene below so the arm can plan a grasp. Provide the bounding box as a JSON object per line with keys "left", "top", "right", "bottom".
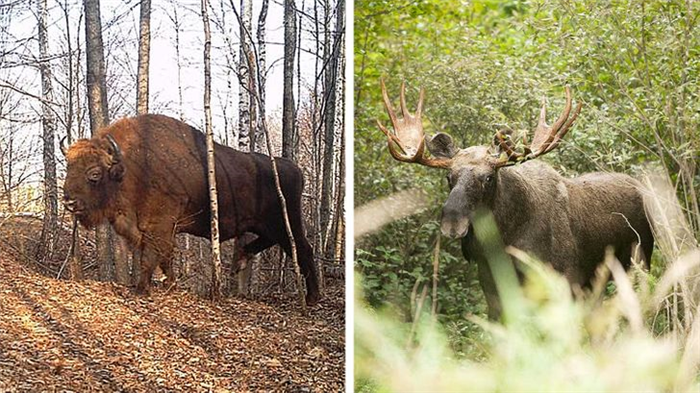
{"left": 354, "top": 172, "right": 700, "bottom": 392}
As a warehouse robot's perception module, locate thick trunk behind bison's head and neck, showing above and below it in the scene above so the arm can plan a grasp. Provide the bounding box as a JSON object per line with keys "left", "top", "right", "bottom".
{"left": 83, "top": 0, "right": 114, "bottom": 281}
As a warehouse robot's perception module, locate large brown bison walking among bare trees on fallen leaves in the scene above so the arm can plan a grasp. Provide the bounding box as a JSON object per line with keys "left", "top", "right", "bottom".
{"left": 61, "top": 115, "right": 320, "bottom": 304}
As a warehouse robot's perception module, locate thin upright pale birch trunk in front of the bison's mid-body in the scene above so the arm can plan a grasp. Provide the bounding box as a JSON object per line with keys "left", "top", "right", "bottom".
{"left": 202, "top": 0, "right": 221, "bottom": 299}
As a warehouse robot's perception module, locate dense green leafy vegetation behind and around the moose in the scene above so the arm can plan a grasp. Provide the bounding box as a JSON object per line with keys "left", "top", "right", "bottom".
{"left": 354, "top": 0, "right": 700, "bottom": 386}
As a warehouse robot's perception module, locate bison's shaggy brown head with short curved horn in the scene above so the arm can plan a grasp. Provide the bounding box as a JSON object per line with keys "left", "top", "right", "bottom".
{"left": 61, "top": 135, "right": 124, "bottom": 227}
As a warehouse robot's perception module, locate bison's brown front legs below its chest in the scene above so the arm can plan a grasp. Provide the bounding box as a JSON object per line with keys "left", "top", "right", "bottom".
{"left": 136, "top": 230, "right": 175, "bottom": 294}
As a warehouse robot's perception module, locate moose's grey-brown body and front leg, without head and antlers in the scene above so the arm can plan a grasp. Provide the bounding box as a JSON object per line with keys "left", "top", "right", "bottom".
{"left": 462, "top": 155, "right": 654, "bottom": 318}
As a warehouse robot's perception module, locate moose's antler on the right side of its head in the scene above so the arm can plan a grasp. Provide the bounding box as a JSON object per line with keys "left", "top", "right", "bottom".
{"left": 495, "top": 86, "right": 581, "bottom": 166}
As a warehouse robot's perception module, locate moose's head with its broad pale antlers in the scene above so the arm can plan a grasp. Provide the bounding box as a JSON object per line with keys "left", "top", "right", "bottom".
{"left": 377, "top": 80, "right": 581, "bottom": 238}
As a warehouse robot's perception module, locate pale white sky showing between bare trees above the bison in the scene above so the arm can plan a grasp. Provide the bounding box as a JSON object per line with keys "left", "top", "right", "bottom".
{"left": 0, "top": 0, "right": 322, "bottom": 176}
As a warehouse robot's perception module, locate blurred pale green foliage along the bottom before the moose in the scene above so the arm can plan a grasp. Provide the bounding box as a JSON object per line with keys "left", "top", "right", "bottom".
{"left": 354, "top": 250, "right": 700, "bottom": 392}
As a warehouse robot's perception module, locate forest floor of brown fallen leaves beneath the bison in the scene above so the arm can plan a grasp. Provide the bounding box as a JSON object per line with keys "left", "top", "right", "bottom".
{"left": 0, "top": 216, "right": 345, "bottom": 392}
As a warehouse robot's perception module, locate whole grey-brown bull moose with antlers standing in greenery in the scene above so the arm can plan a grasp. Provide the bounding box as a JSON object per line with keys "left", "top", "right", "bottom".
{"left": 377, "top": 80, "right": 654, "bottom": 319}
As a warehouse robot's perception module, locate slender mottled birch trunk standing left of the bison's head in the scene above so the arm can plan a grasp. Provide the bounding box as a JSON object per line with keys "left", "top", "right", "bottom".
{"left": 37, "top": 0, "right": 58, "bottom": 261}
